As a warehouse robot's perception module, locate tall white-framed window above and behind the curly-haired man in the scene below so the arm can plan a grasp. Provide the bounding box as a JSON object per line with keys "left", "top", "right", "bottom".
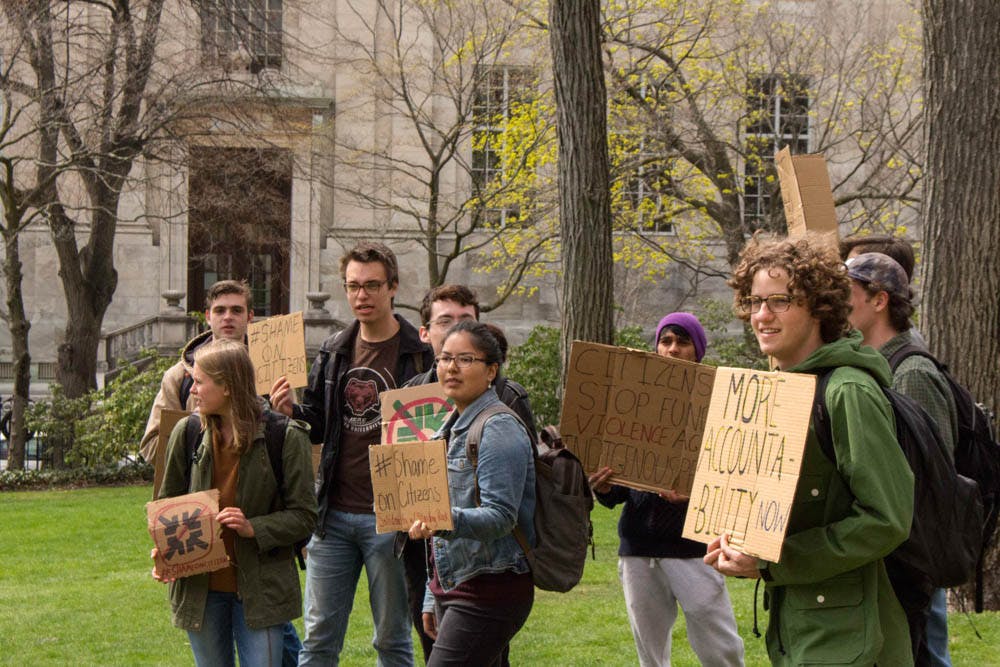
{"left": 743, "top": 74, "right": 810, "bottom": 233}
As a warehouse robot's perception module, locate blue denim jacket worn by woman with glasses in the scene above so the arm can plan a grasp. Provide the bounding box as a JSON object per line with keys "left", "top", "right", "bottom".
{"left": 424, "top": 387, "right": 535, "bottom": 611}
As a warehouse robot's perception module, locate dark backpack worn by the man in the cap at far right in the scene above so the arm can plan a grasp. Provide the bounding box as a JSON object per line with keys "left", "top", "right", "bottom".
{"left": 889, "top": 344, "right": 1000, "bottom": 612}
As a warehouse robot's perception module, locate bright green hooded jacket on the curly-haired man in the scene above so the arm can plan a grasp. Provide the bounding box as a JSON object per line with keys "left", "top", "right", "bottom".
{"left": 760, "top": 333, "right": 913, "bottom": 667}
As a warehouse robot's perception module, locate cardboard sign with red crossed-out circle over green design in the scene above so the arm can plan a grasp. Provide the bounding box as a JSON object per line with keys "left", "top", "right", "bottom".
{"left": 379, "top": 382, "right": 455, "bottom": 443}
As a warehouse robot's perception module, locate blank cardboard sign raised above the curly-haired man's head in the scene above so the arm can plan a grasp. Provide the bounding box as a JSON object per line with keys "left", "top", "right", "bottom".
{"left": 775, "top": 146, "right": 838, "bottom": 244}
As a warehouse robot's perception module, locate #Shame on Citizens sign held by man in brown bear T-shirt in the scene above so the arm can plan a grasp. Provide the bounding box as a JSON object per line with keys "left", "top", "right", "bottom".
{"left": 247, "top": 311, "right": 308, "bottom": 396}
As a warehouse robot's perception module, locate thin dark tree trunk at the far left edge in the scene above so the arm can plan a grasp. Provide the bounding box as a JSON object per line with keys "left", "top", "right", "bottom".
{"left": 3, "top": 220, "right": 31, "bottom": 470}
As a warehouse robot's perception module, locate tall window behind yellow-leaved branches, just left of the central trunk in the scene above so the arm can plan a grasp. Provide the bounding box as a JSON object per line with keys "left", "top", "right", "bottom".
{"left": 470, "top": 65, "right": 535, "bottom": 227}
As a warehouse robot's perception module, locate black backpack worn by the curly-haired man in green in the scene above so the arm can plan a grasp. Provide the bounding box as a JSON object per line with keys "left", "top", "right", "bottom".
{"left": 813, "top": 368, "right": 983, "bottom": 595}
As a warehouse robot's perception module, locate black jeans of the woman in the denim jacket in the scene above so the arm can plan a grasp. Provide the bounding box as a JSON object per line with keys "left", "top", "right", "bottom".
{"left": 427, "top": 590, "right": 535, "bottom": 667}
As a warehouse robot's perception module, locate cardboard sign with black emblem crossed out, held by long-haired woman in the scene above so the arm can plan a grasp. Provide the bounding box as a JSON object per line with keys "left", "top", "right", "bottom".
{"left": 146, "top": 489, "right": 229, "bottom": 579}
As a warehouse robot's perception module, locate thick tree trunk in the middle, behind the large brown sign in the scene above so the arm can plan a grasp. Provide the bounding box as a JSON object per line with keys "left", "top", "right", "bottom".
{"left": 549, "top": 0, "right": 614, "bottom": 379}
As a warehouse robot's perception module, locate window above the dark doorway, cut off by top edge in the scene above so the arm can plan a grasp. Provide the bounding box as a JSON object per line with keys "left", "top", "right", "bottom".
{"left": 198, "top": 0, "right": 282, "bottom": 74}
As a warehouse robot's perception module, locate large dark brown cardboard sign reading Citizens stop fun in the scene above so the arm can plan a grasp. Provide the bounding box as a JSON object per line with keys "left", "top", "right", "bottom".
{"left": 559, "top": 341, "right": 715, "bottom": 494}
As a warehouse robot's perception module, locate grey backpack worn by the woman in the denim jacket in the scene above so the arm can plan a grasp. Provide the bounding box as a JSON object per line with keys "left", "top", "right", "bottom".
{"left": 465, "top": 403, "right": 594, "bottom": 593}
